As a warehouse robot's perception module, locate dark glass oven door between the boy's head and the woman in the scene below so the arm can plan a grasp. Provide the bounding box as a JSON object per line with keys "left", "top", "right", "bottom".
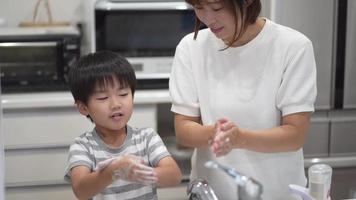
{"left": 95, "top": 9, "right": 195, "bottom": 57}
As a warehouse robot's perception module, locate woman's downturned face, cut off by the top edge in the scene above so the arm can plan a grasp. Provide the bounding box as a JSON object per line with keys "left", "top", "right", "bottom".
{"left": 194, "top": 0, "right": 239, "bottom": 43}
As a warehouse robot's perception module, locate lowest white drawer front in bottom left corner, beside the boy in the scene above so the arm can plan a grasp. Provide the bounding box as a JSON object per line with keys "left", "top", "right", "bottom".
{"left": 5, "top": 185, "right": 77, "bottom": 200}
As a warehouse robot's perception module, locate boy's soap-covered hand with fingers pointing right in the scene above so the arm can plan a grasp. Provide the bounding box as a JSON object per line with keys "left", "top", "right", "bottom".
{"left": 112, "top": 155, "right": 157, "bottom": 185}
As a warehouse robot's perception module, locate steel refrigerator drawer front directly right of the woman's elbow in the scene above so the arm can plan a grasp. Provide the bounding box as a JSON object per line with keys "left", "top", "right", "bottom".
{"left": 303, "top": 111, "right": 330, "bottom": 158}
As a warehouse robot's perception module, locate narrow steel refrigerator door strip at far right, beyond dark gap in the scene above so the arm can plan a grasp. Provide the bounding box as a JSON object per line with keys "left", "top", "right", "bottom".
{"left": 344, "top": 0, "right": 356, "bottom": 108}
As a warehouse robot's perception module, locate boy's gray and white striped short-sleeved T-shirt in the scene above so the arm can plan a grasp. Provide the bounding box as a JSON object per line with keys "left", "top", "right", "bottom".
{"left": 64, "top": 126, "right": 170, "bottom": 200}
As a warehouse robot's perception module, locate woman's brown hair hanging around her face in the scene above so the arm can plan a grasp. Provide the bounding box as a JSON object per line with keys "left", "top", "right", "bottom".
{"left": 185, "top": 0, "right": 261, "bottom": 47}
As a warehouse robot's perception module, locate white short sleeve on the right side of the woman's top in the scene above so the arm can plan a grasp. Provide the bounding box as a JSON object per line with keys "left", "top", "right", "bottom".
{"left": 276, "top": 40, "right": 317, "bottom": 116}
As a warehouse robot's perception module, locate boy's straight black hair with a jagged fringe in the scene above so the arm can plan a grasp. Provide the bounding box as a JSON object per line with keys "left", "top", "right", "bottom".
{"left": 68, "top": 51, "right": 136, "bottom": 104}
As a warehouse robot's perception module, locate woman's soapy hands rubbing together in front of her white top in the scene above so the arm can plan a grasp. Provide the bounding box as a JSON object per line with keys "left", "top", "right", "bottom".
{"left": 211, "top": 119, "right": 240, "bottom": 157}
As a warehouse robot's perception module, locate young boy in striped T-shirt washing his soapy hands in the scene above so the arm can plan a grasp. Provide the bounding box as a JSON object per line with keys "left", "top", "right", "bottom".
{"left": 65, "top": 51, "right": 181, "bottom": 199}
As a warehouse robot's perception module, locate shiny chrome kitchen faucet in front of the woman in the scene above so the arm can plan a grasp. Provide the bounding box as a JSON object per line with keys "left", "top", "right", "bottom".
{"left": 187, "top": 161, "right": 263, "bottom": 200}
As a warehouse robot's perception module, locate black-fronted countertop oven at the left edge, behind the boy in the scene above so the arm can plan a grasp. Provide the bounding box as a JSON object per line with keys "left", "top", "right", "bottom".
{"left": 0, "top": 27, "right": 80, "bottom": 93}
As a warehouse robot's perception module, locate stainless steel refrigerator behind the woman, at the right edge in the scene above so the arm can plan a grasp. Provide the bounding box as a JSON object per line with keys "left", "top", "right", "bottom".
{"left": 265, "top": 0, "right": 356, "bottom": 199}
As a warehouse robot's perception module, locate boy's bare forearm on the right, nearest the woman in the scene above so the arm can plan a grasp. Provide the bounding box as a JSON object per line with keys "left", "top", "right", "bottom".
{"left": 154, "top": 156, "right": 182, "bottom": 187}
